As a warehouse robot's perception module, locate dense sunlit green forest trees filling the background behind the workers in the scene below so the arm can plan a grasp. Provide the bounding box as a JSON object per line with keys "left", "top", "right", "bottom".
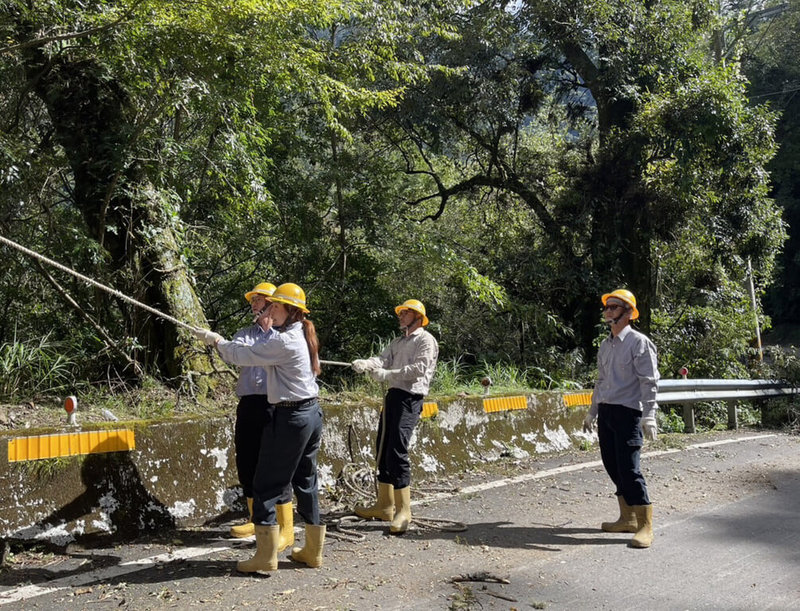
{"left": 0, "top": 0, "right": 797, "bottom": 400}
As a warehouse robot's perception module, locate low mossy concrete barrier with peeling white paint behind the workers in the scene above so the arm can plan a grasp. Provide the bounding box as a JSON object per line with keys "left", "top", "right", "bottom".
{"left": 0, "top": 393, "right": 586, "bottom": 545}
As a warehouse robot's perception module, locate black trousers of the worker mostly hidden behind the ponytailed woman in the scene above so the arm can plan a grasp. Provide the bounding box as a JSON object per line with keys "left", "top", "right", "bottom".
{"left": 233, "top": 395, "right": 275, "bottom": 499}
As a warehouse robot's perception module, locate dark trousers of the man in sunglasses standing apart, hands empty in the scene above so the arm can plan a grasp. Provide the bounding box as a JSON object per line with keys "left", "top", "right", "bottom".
{"left": 597, "top": 403, "right": 650, "bottom": 505}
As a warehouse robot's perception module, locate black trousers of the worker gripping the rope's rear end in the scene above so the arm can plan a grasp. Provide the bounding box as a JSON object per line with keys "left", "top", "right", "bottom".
{"left": 375, "top": 388, "right": 424, "bottom": 488}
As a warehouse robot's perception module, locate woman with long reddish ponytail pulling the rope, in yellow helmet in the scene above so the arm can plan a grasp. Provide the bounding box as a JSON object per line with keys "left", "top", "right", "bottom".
{"left": 198, "top": 283, "right": 325, "bottom": 573}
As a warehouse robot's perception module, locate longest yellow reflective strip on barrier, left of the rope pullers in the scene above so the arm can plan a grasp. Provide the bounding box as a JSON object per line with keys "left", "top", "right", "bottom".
{"left": 8, "top": 429, "right": 136, "bottom": 462}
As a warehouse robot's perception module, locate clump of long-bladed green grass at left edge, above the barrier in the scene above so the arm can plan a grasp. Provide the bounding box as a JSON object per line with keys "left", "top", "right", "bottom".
{"left": 0, "top": 334, "right": 76, "bottom": 401}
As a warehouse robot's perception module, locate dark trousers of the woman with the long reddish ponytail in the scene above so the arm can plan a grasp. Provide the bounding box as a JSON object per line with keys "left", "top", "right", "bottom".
{"left": 253, "top": 400, "right": 322, "bottom": 525}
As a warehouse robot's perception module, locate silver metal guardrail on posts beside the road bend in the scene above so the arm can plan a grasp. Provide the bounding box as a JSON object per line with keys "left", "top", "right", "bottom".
{"left": 656, "top": 379, "right": 800, "bottom": 433}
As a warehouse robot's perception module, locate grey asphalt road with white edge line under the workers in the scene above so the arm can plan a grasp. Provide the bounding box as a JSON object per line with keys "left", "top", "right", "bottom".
{"left": 0, "top": 431, "right": 800, "bottom": 610}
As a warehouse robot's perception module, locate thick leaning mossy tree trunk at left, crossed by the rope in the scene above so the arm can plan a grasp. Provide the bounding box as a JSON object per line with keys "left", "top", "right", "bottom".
{"left": 24, "top": 48, "right": 211, "bottom": 390}
